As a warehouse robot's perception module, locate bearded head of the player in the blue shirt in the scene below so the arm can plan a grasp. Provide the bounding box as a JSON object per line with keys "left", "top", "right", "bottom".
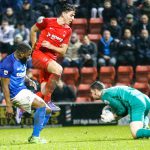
{"left": 15, "top": 42, "right": 32, "bottom": 63}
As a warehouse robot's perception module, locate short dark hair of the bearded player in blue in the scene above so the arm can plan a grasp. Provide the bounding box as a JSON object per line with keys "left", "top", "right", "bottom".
{"left": 15, "top": 42, "right": 32, "bottom": 53}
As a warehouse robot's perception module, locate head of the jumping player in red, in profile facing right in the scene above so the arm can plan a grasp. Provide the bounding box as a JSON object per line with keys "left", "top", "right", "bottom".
{"left": 59, "top": 2, "right": 76, "bottom": 25}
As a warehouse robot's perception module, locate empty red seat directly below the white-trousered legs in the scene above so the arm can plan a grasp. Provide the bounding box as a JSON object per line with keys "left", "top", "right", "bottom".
{"left": 89, "top": 18, "right": 103, "bottom": 34}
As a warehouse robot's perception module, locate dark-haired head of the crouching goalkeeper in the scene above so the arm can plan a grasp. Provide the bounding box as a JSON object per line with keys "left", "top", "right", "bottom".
{"left": 90, "top": 81, "right": 105, "bottom": 100}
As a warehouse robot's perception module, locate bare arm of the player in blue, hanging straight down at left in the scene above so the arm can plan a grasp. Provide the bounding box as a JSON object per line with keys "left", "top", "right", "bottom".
{"left": 1, "top": 78, "right": 13, "bottom": 118}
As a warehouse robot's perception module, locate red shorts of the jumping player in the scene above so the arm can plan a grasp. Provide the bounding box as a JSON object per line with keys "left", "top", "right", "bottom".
{"left": 32, "top": 50, "right": 55, "bottom": 83}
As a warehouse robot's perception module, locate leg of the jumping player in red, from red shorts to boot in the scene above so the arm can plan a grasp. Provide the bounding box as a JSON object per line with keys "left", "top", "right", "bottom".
{"left": 32, "top": 50, "right": 62, "bottom": 111}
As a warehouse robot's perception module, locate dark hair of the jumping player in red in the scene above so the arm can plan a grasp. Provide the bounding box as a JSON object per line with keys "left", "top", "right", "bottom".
{"left": 58, "top": 2, "right": 76, "bottom": 16}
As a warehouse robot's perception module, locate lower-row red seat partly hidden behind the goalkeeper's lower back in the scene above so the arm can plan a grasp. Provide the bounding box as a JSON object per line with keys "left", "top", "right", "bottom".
{"left": 133, "top": 82, "right": 150, "bottom": 96}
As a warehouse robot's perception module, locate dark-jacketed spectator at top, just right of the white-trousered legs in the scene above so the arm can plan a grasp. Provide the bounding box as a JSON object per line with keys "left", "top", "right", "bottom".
{"left": 102, "top": 0, "right": 121, "bottom": 23}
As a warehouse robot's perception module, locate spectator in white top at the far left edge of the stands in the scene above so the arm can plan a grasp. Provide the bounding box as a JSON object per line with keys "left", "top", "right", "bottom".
{"left": 0, "top": 20, "right": 14, "bottom": 55}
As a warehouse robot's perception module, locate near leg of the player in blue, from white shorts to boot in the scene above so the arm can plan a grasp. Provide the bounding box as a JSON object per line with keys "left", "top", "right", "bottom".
{"left": 13, "top": 89, "right": 51, "bottom": 143}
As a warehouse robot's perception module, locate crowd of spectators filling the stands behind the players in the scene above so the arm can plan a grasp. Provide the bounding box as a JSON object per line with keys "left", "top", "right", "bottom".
{"left": 0, "top": 0, "right": 150, "bottom": 102}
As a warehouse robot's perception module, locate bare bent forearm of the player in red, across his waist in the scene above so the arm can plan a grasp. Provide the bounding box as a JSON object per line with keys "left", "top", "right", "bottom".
{"left": 42, "top": 41, "right": 68, "bottom": 55}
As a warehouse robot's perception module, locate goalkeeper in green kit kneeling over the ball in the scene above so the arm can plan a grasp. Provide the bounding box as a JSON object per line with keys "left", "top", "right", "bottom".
{"left": 91, "top": 81, "right": 150, "bottom": 139}
